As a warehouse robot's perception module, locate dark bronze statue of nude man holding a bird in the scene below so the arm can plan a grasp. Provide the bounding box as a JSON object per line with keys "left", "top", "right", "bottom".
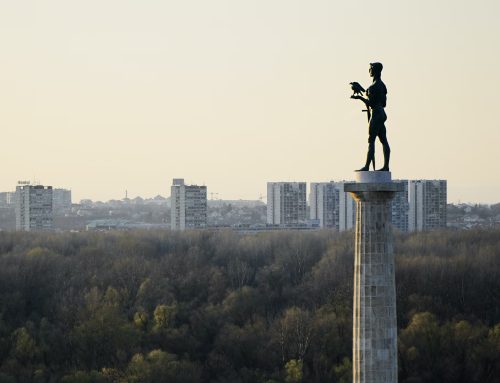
{"left": 351, "top": 63, "right": 391, "bottom": 171}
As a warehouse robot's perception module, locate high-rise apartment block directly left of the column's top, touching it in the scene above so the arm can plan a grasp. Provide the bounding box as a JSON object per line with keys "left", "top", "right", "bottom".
{"left": 309, "top": 181, "right": 356, "bottom": 231}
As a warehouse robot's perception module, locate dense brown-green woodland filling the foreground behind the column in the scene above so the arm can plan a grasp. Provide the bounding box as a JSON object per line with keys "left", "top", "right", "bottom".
{"left": 0, "top": 230, "right": 500, "bottom": 383}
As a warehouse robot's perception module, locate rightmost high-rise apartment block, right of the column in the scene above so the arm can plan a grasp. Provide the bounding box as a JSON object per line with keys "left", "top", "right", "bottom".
{"left": 408, "top": 180, "right": 447, "bottom": 231}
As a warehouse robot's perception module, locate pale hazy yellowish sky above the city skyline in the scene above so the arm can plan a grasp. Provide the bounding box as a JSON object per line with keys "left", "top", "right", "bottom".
{"left": 0, "top": 0, "right": 500, "bottom": 203}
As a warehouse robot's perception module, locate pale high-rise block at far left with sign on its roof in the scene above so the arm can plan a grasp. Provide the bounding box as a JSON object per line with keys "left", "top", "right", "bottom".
{"left": 15, "top": 182, "right": 53, "bottom": 231}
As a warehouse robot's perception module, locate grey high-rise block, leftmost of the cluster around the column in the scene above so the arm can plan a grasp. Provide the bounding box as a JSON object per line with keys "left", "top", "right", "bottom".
{"left": 267, "top": 182, "right": 307, "bottom": 226}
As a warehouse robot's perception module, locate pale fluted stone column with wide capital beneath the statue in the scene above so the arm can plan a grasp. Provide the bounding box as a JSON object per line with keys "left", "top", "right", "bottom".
{"left": 344, "top": 172, "right": 403, "bottom": 383}
